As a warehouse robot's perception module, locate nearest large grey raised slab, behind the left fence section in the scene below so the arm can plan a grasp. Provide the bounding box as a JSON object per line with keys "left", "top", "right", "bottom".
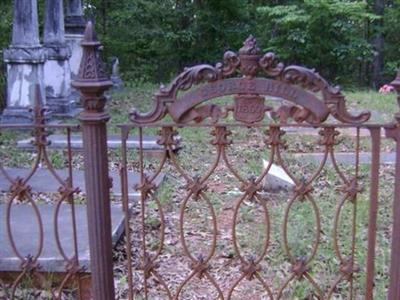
{"left": 0, "top": 204, "right": 124, "bottom": 272}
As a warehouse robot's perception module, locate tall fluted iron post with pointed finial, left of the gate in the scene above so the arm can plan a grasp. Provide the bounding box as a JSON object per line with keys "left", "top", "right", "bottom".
{"left": 72, "top": 22, "right": 115, "bottom": 300}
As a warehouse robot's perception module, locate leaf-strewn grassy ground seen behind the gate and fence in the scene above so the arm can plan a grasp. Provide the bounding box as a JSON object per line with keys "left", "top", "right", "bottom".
{"left": 0, "top": 84, "right": 397, "bottom": 299}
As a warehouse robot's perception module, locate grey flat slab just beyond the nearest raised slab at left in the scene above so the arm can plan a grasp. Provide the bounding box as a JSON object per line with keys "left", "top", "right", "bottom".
{"left": 0, "top": 169, "right": 164, "bottom": 200}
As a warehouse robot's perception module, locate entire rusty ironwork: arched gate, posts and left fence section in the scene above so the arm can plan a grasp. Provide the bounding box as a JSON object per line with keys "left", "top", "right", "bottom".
{"left": 0, "top": 31, "right": 400, "bottom": 300}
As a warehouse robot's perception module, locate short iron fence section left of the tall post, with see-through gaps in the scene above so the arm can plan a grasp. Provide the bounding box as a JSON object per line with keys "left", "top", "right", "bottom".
{"left": 0, "top": 88, "right": 90, "bottom": 299}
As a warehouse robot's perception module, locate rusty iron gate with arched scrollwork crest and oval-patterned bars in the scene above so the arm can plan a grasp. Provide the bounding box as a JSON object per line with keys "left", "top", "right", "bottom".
{"left": 122, "top": 36, "right": 400, "bottom": 300}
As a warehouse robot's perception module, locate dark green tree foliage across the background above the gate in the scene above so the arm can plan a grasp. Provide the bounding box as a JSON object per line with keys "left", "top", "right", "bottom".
{"left": 0, "top": 0, "right": 400, "bottom": 86}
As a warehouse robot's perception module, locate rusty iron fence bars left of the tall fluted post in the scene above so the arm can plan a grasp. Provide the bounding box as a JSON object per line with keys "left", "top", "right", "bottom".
{"left": 0, "top": 86, "right": 84, "bottom": 299}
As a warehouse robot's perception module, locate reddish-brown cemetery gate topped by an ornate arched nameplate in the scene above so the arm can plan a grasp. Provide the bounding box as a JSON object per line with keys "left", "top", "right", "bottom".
{"left": 115, "top": 36, "right": 400, "bottom": 300}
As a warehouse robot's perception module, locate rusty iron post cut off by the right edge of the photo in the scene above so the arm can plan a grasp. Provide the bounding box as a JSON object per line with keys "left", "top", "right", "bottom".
{"left": 385, "top": 70, "right": 400, "bottom": 300}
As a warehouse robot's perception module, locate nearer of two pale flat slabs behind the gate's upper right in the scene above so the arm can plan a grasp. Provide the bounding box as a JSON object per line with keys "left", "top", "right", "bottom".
{"left": 293, "top": 152, "right": 396, "bottom": 164}
